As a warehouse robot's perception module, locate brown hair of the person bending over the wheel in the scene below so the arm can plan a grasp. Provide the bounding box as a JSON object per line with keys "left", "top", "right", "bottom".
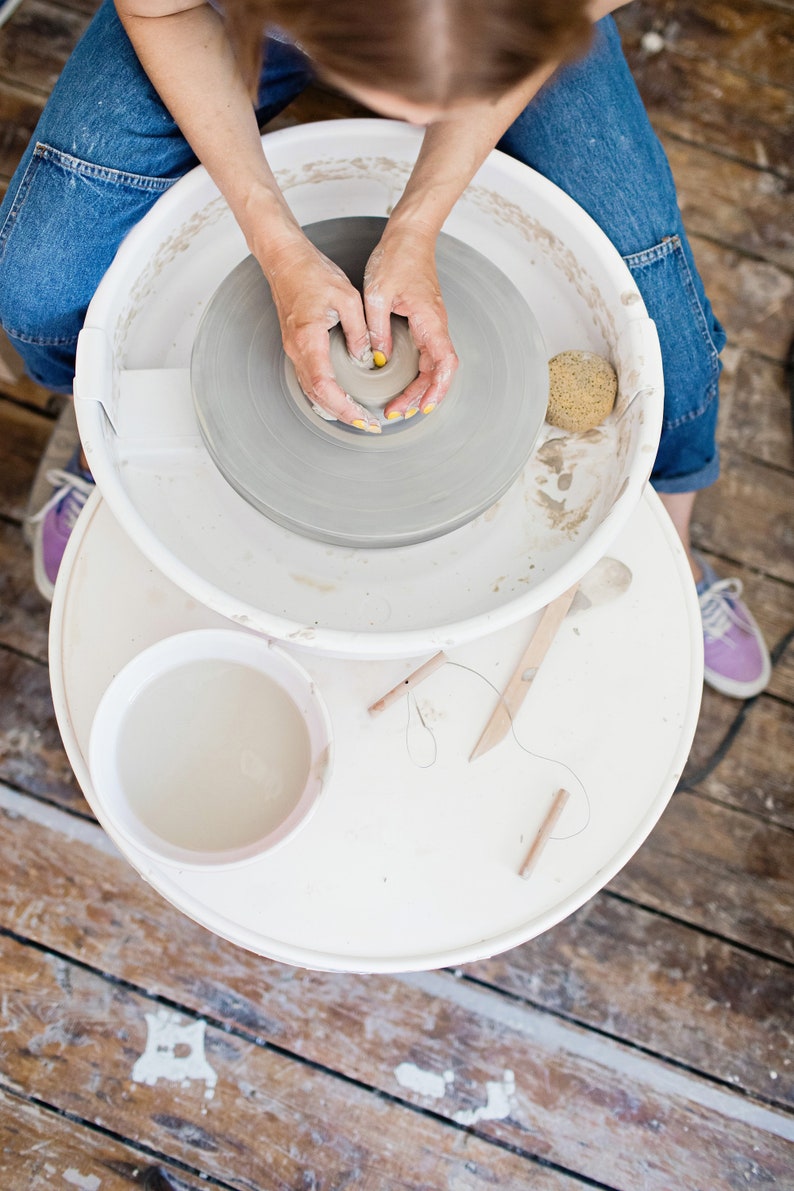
{"left": 225, "top": 0, "right": 592, "bottom": 106}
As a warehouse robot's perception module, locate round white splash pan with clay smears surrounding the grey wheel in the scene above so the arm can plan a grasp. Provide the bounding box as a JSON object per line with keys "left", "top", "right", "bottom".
{"left": 75, "top": 120, "right": 663, "bottom": 657}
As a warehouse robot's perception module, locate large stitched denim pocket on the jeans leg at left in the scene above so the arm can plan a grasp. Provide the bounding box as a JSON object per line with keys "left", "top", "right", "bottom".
{"left": 0, "top": 144, "right": 174, "bottom": 345}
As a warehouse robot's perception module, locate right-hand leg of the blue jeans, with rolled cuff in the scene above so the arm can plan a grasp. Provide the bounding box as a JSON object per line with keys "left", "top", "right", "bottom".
{"left": 501, "top": 18, "right": 725, "bottom": 492}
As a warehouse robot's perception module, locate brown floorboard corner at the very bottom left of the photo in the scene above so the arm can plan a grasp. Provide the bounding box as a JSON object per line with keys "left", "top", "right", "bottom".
{"left": 0, "top": 1091, "right": 208, "bottom": 1191}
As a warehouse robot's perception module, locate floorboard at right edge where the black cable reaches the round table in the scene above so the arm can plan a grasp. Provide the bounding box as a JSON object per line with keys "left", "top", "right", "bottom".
{"left": 683, "top": 690, "right": 794, "bottom": 829}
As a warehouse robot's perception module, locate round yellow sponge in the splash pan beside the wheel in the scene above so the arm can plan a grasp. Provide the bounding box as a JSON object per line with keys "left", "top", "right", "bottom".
{"left": 546, "top": 351, "right": 618, "bottom": 430}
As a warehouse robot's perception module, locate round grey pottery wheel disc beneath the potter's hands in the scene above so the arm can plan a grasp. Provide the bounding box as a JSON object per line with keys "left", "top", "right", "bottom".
{"left": 190, "top": 217, "right": 549, "bottom": 548}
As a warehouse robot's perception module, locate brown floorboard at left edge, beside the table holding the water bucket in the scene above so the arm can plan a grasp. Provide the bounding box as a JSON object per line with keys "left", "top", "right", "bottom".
{"left": 0, "top": 649, "right": 90, "bottom": 815}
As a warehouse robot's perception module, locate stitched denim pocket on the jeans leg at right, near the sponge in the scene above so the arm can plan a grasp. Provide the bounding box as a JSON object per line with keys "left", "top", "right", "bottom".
{"left": 624, "top": 236, "right": 725, "bottom": 429}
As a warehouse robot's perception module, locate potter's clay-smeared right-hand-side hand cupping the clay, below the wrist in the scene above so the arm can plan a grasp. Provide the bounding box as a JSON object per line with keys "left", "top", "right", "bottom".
{"left": 364, "top": 224, "right": 457, "bottom": 418}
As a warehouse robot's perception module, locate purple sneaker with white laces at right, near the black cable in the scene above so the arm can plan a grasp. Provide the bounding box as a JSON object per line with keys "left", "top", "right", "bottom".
{"left": 698, "top": 557, "right": 771, "bottom": 699}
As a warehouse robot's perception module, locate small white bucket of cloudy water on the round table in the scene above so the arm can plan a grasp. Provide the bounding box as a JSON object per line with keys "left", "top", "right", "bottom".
{"left": 89, "top": 629, "right": 331, "bottom": 868}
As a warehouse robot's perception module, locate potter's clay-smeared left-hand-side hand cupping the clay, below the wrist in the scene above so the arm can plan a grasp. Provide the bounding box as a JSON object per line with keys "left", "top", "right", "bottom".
{"left": 261, "top": 235, "right": 381, "bottom": 434}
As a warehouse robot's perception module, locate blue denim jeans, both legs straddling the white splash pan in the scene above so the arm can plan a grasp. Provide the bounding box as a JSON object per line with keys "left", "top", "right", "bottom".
{"left": 0, "top": 0, "right": 725, "bottom": 492}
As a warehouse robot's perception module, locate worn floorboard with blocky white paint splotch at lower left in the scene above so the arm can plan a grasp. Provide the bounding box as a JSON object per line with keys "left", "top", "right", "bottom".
{"left": 0, "top": 939, "right": 590, "bottom": 1191}
